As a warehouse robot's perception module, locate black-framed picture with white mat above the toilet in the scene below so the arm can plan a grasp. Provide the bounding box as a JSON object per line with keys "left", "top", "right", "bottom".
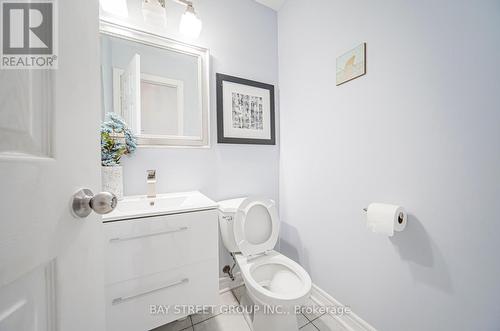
{"left": 217, "top": 74, "right": 276, "bottom": 145}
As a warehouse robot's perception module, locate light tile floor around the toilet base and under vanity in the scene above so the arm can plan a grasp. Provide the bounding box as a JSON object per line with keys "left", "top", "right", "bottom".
{"left": 152, "top": 286, "right": 346, "bottom": 331}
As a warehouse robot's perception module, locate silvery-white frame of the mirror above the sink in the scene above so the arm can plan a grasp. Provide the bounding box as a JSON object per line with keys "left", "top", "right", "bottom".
{"left": 99, "top": 19, "right": 210, "bottom": 147}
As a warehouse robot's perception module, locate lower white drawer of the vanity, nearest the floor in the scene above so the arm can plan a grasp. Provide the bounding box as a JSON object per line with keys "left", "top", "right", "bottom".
{"left": 106, "top": 259, "right": 219, "bottom": 331}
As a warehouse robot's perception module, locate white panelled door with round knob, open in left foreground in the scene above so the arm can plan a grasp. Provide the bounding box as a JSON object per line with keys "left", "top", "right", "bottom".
{"left": 0, "top": 0, "right": 105, "bottom": 331}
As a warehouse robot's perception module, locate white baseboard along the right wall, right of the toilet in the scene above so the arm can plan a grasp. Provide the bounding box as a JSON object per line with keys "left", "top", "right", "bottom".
{"left": 311, "top": 284, "right": 377, "bottom": 331}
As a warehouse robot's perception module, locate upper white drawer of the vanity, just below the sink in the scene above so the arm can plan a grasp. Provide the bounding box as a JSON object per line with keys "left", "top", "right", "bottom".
{"left": 104, "top": 210, "right": 218, "bottom": 284}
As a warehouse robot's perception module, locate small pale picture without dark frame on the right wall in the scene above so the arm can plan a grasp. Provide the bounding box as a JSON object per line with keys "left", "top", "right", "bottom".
{"left": 337, "top": 43, "right": 366, "bottom": 86}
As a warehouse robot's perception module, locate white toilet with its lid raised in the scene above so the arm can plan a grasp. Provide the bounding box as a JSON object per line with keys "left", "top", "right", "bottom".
{"left": 219, "top": 198, "right": 311, "bottom": 331}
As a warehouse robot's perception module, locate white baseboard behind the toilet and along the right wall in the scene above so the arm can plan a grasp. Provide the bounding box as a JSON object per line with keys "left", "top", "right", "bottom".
{"left": 219, "top": 272, "right": 377, "bottom": 331}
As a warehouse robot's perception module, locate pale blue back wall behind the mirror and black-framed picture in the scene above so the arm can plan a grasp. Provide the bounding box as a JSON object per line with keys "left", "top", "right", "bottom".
{"left": 102, "top": 0, "right": 279, "bottom": 274}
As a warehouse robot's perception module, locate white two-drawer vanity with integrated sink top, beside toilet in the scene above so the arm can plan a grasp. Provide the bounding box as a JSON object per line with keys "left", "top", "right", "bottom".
{"left": 103, "top": 192, "right": 219, "bottom": 331}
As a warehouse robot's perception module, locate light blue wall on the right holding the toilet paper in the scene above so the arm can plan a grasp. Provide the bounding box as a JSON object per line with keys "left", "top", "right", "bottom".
{"left": 278, "top": 0, "right": 500, "bottom": 331}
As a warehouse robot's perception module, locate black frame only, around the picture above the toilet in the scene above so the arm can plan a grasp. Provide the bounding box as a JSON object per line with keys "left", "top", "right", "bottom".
{"left": 216, "top": 73, "right": 276, "bottom": 145}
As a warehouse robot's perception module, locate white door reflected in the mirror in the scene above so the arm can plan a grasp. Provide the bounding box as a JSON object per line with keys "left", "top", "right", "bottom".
{"left": 120, "top": 54, "right": 141, "bottom": 134}
